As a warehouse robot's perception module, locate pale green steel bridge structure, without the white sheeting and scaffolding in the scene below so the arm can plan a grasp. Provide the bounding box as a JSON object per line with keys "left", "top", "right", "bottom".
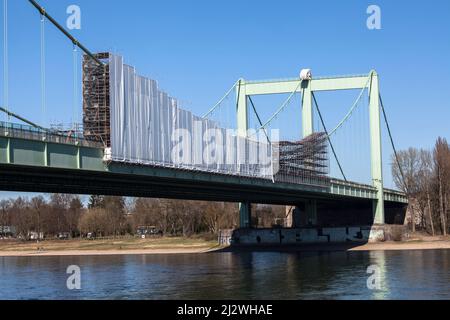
{"left": 0, "top": 0, "right": 408, "bottom": 227}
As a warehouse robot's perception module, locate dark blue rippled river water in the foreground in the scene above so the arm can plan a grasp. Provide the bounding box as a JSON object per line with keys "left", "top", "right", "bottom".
{"left": 0, "top": 250, "right": 450, "bottom": 300}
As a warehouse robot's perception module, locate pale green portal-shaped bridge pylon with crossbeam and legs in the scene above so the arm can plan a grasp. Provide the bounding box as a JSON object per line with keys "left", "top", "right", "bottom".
{"left": 236, "top": 70, "right": 385, "bottom": 224}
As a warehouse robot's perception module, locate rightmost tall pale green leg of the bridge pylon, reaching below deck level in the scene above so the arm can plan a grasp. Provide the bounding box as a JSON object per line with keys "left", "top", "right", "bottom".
{"left": 369, "top": 71, "right": 385, "bottom": 224}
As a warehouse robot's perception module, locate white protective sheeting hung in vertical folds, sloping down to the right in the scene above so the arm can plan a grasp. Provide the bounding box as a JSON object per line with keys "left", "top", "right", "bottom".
{"left": 110, "top": 55, "right": 274, "bottom": 179}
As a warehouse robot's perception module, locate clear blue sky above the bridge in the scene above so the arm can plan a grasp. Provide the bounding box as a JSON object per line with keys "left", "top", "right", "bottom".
{"left": 0, "top": 0, "right": 450, "bottom": 200}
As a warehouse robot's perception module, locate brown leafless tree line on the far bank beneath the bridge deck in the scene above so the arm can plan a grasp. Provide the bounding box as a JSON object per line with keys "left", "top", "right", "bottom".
{"left": 0, "top": 194, "right": 244, "bottom": 238}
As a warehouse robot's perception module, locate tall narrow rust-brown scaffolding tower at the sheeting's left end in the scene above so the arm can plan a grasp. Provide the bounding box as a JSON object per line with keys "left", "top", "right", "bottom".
{"left": 83, "top": 53, "right": 111, "bottom": 147}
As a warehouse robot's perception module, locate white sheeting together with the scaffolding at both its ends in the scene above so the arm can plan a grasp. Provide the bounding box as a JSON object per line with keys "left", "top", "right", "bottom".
{"left": 83, "top": 53, "right": 329, "bottom": 186}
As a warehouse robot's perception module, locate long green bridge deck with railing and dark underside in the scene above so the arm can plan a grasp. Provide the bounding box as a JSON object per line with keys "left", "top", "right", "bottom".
{"left": 0, "top": 128, "right": 407, "bottom": 204}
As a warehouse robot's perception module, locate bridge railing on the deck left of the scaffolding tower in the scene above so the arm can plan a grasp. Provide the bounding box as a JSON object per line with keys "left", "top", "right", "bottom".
{"left": 0, "top": 121, "right": 103, "bottom": 148}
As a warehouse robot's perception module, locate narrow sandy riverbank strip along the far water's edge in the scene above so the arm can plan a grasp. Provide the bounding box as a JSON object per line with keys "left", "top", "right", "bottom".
{"left": 0, "top": 236, "right": 450, "bottom": 257}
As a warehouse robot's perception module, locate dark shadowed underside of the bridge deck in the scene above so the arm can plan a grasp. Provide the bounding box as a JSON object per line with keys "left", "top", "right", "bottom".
{"left": 0, "top": 164, "right": 362, "bottom": 204}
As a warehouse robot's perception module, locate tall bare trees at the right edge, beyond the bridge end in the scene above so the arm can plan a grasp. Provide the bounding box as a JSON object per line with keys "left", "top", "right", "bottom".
{"left": 392, "top": 138, "right": 450, "bottom": 235}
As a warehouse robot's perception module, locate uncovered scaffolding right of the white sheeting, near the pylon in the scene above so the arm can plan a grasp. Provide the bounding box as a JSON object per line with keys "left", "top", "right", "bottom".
{"left": 275, "top": 132, "right": 330, "bottom": 186}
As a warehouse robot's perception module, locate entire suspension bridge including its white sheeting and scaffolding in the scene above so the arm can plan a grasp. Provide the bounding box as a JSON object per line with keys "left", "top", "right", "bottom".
{"left": 0, "top": 0, "right": 407, "bottom": 227}
